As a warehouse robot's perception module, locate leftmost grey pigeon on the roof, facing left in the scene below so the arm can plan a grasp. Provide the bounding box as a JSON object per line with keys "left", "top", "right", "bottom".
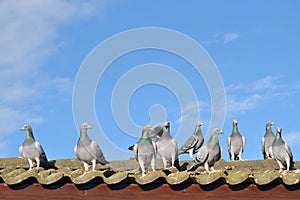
{"left": 19, "top": 124, "right": 48, "bottom": 170}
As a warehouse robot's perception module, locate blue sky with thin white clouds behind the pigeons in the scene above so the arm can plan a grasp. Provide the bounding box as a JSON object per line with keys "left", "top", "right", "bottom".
{"left": 0, "top": 0, "right": 300, "bottom": 160}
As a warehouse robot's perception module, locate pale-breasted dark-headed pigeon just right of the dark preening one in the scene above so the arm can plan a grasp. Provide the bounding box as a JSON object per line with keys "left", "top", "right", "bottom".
{"left": 156, "top": 122, "right": 178, "bottom": 168}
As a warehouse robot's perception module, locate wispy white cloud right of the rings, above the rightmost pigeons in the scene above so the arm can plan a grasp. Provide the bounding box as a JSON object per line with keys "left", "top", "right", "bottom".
{"left": 226, "top": 76, "right": 295, "bottom": 113}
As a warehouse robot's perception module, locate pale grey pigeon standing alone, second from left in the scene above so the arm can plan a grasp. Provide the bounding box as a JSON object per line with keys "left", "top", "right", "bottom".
{"left": 74, "top": 123, "right": 109, "bottom": 172}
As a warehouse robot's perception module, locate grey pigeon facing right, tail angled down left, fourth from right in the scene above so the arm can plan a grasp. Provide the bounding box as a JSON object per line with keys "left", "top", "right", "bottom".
{"left": 189, "top": 128, "right": 223, "bottom": 174}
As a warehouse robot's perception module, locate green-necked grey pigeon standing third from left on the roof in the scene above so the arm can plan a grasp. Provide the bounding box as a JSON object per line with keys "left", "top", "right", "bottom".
{"left": 133, "top": 125, "right": 156, "bottom": 176}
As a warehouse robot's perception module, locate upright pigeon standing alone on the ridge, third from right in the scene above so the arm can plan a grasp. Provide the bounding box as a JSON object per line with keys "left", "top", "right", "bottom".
{"left": 227, "top": 120, "right": 246, "bottom": 161}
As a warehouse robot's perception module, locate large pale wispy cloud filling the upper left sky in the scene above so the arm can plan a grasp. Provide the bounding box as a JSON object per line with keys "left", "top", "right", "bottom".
{"left": 0, "top": 0, "right": 102, "bottom": 152}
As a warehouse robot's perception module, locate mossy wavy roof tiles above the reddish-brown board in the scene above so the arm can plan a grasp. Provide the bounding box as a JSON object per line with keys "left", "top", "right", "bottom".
{"left": 0, "top": 158, "right": 300, "bottom": 187}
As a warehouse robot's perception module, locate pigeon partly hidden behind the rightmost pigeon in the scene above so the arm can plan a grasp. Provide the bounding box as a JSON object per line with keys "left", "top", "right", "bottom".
{"left": 261, "top": 121, "right": 275, "bottom": 159}
